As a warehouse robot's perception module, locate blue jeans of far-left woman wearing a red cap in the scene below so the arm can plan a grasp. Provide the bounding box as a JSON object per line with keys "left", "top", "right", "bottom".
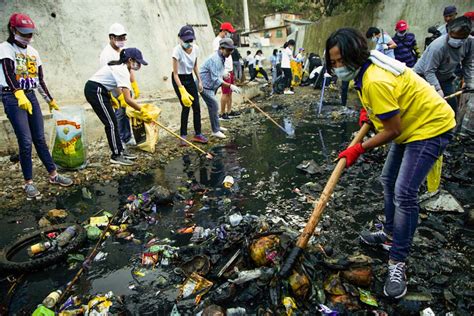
{"left": 2, "top": 91, "right": 56, "bottom": 180}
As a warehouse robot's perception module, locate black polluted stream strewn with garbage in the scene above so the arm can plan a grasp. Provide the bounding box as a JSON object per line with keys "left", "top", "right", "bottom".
{"left": 0, "top": 94, "right": 474, "bottom": 315}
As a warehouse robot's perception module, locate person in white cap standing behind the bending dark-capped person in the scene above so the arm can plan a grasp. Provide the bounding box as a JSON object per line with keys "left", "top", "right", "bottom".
{"left": 99, "top": 23, "right": 140, "bottom": 147}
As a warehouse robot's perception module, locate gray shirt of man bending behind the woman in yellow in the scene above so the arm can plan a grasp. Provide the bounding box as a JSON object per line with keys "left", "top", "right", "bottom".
{"left": 413, "top": 35, "right": 474, "bottom": 90}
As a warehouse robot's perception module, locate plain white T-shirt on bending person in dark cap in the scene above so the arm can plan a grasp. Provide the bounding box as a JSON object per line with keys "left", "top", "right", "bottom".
{"left": 89, "top": 64, "right": 132, "bottom": 91}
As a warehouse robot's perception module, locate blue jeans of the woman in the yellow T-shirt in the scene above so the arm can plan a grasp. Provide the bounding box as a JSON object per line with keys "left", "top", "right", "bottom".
{"left": 380, "top": 132, "right": 453, "bottom": 262}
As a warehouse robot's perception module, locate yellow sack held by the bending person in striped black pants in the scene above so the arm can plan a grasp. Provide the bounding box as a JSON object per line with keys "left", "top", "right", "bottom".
{"left": 126, "top": 103, "right": 161, "bottom": 153}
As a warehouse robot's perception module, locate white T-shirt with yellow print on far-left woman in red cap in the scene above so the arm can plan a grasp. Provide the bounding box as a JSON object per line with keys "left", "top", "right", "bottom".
{"left": 0, "top": 42, "right": 42, "bottom": 90}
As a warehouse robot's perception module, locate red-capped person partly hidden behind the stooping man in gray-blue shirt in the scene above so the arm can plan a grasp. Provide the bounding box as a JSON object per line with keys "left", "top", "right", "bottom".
{"left": 212, "top": 22, "right": 236, "bottom": 122}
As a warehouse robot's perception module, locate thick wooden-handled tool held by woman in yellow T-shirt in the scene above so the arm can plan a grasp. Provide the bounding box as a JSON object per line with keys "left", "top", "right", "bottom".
{"left": 280, "top": 123, "right": 370, "bottom": 277}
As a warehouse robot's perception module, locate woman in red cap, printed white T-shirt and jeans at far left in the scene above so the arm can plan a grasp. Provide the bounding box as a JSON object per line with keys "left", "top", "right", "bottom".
{"left": 0, "top": 13, "right": 73, "bottom": 199}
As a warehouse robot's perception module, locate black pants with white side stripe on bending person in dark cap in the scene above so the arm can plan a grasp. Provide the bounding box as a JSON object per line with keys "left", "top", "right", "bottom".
{"left": 84, "top": 81, "right": 123, "bottom": 157}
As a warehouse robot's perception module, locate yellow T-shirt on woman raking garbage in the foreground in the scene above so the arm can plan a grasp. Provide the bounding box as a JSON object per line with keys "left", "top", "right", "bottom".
{"left": 359, "top": 64, "right": 456, "bottom": 144}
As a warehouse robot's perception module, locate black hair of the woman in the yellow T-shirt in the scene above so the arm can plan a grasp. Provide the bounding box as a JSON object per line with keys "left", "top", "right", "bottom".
{"left": 325, "top": 28, "right": 370, "bottom": 72}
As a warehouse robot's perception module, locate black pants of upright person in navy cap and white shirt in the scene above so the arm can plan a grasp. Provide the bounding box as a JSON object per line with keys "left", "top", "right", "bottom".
{"left": 171, "top": 73, "right": 201, "bottom": 136}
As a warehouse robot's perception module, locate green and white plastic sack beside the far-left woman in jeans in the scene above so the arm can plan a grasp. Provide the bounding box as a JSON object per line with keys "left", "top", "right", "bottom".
{"left": 51, "top": 108, "right": 87, "bottom": 169}
